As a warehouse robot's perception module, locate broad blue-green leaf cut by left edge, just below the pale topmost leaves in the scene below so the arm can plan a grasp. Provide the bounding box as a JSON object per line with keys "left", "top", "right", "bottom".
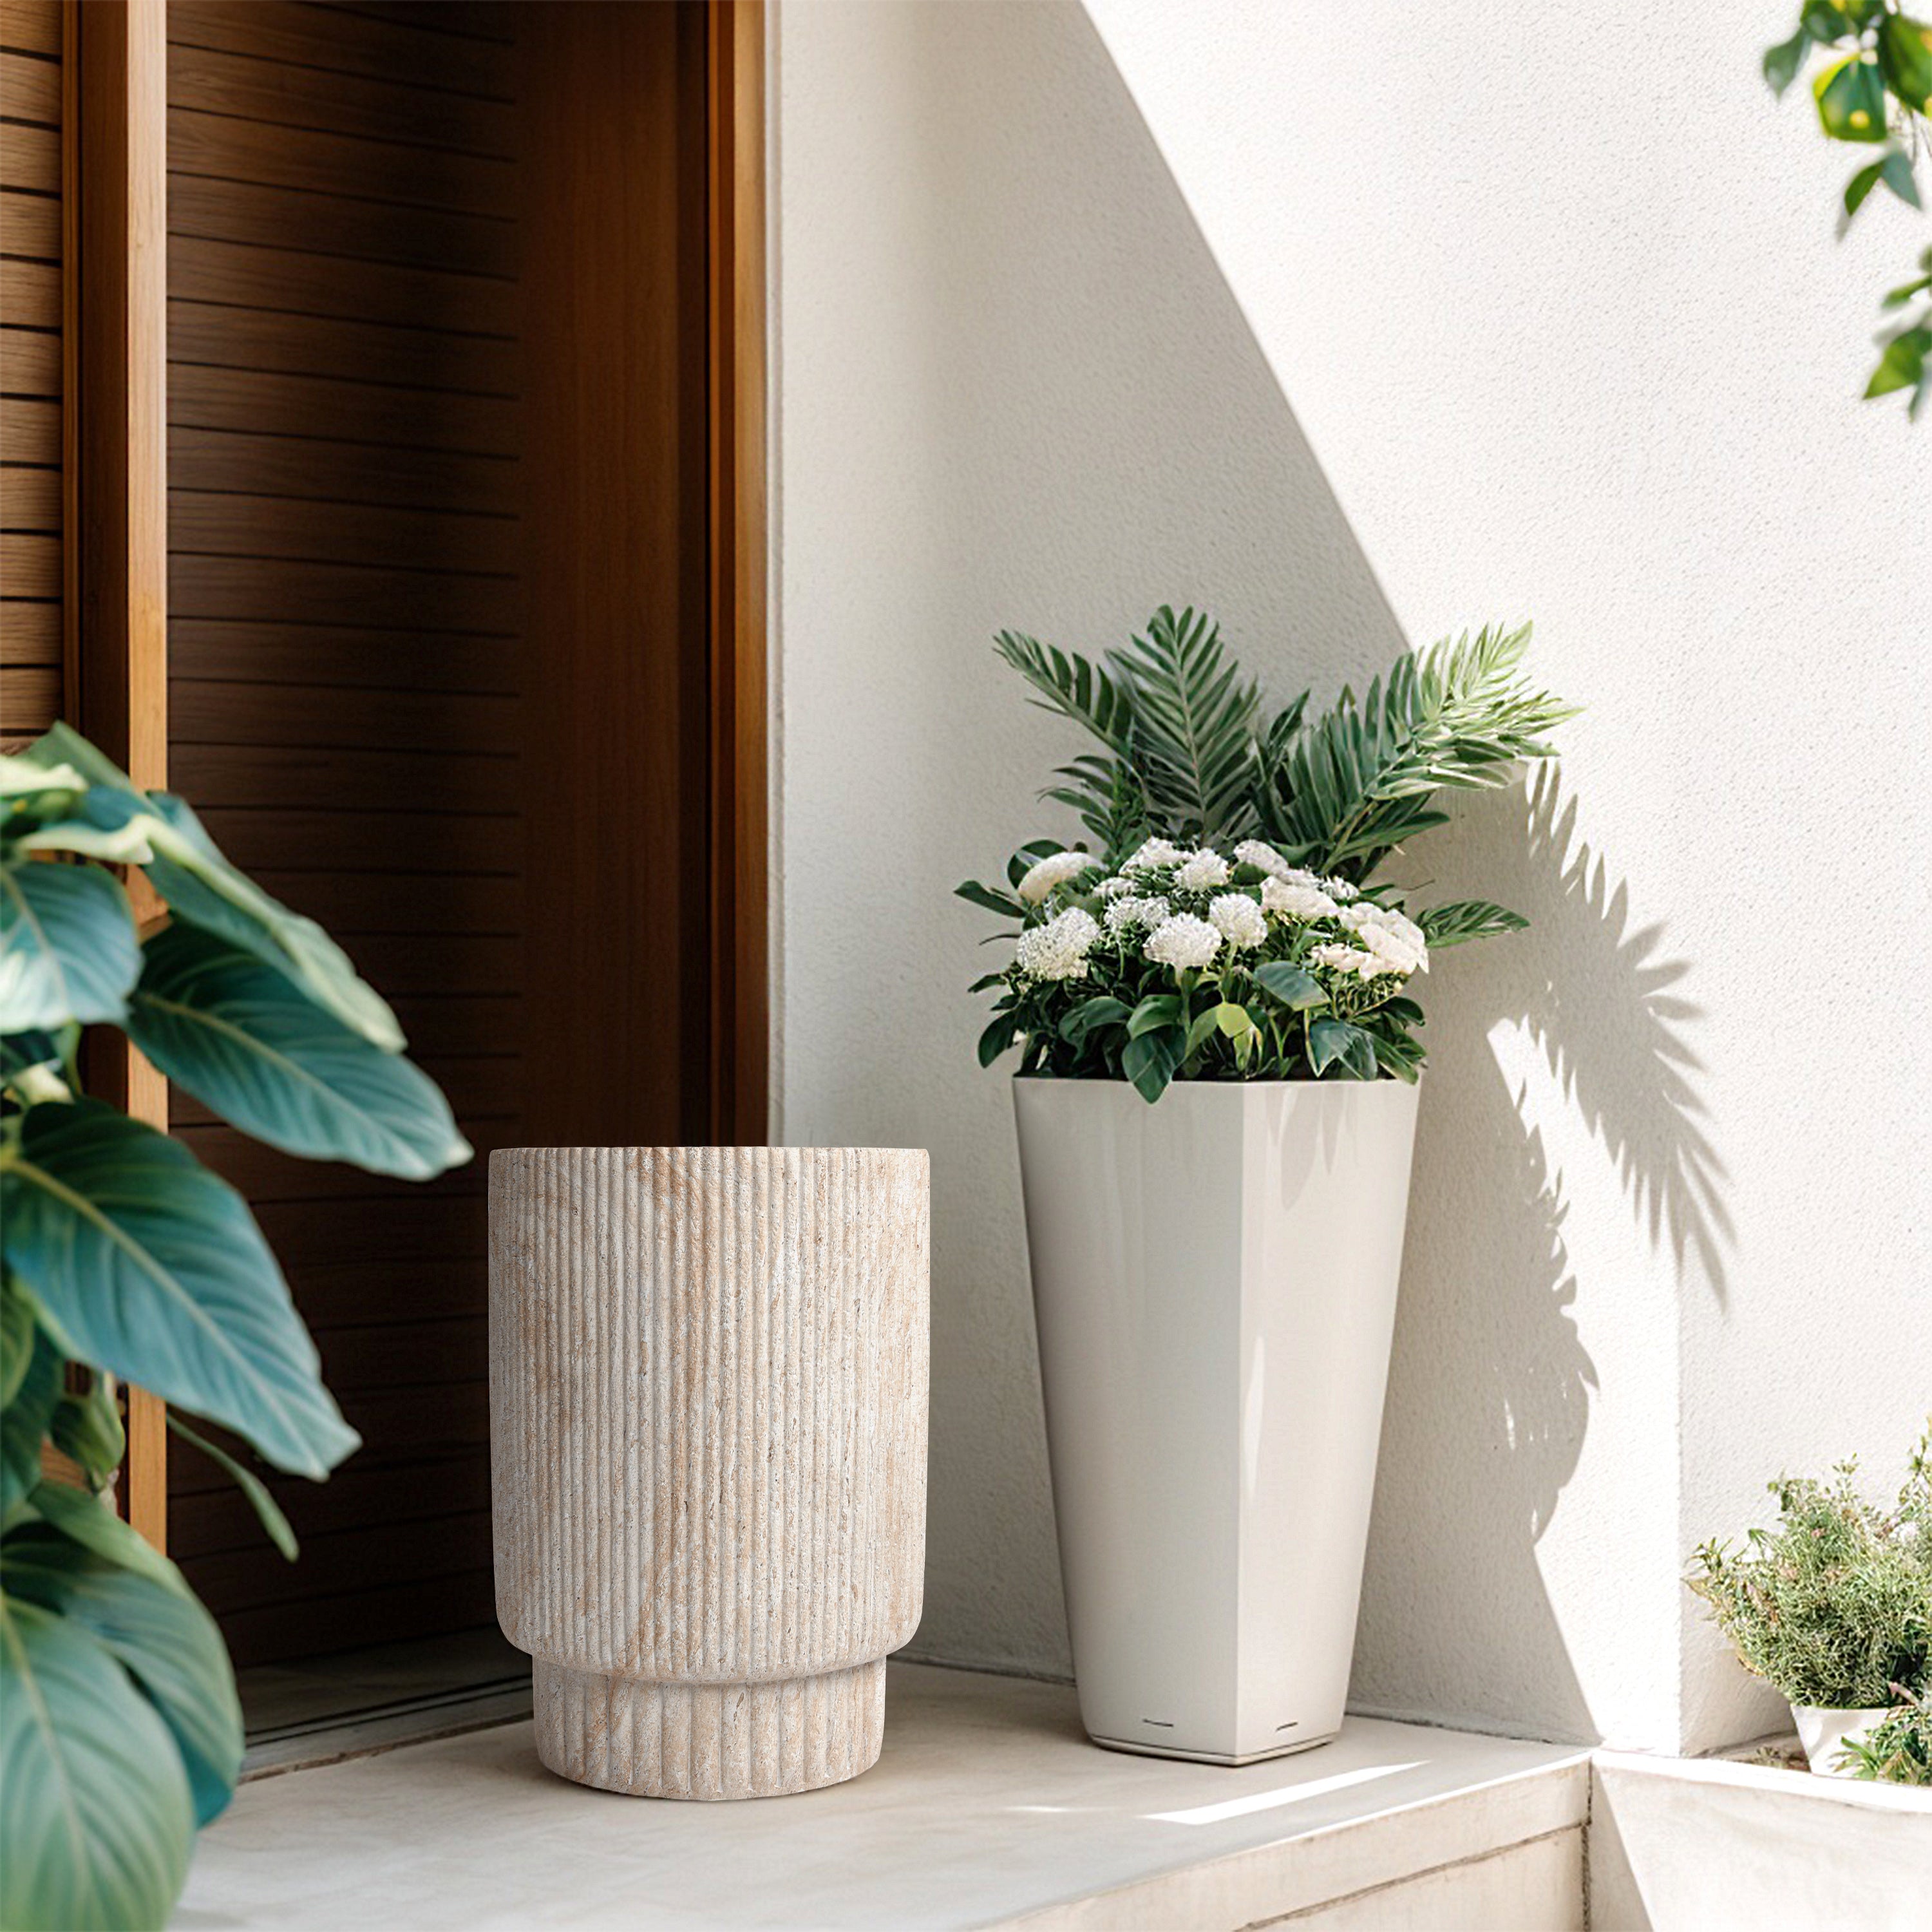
{"left": 0, "top": 860, "right": 141, "bottom": 1034}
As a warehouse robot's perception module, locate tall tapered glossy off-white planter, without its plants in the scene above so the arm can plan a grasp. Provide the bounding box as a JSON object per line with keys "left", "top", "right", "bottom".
{"left": 1012, "top": 1080, "right": 1416, "bottom": 1764}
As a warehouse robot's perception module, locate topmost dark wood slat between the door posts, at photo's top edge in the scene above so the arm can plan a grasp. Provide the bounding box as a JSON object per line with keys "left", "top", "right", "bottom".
{"left": 168, "top": 0, "right": 516, "bottom": 100}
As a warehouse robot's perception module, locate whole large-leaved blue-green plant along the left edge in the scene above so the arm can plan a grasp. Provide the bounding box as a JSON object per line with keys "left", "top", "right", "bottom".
{"left": 0, "top": 726, "right": 469, "bottom": 1932}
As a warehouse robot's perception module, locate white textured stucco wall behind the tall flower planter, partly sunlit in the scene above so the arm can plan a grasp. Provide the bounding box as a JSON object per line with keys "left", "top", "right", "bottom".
{"left": 775, "top": 0, "right": 1932, "bottom": 1748}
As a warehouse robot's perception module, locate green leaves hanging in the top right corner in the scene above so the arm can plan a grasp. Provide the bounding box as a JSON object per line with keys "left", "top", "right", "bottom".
{"left": 1764, "top": 0, "right": 1932, "bottom": 417}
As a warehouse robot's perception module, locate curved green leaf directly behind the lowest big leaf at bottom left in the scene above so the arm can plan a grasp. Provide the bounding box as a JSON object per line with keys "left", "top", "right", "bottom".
{"left": 0, "top": 1507, "right": 242, "bottom": 1824}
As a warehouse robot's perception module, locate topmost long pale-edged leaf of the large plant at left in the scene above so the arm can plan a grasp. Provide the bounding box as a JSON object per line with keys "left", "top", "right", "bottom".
{"left": 21, "top": 724, "right": 404, "bottom": 1053}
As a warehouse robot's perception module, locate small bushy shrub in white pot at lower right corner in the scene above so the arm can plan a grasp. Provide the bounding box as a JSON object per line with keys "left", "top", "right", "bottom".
{"left": 1687, "top": 1430, "right": 1932, "bottom": 1776}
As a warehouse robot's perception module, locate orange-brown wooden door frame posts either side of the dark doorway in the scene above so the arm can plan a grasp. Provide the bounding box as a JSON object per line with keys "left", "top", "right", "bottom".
{"left": 75, "top": 0, "right": 771, "bottom": 1549}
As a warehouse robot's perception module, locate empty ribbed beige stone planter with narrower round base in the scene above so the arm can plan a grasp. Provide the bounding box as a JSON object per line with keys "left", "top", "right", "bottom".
{"left": 489, "top": 1148, "right": 927, "bottom": 1799}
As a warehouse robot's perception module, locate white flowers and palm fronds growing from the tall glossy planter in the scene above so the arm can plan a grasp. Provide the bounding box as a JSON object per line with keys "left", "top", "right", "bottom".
{"left": 958, "top": 607, "right": 1573, "bottom": 1101}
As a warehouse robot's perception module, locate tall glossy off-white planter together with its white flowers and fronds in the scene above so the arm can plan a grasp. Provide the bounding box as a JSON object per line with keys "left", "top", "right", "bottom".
{"left": 958, "top": 609, "right": 1569, "bottom": 1764}
